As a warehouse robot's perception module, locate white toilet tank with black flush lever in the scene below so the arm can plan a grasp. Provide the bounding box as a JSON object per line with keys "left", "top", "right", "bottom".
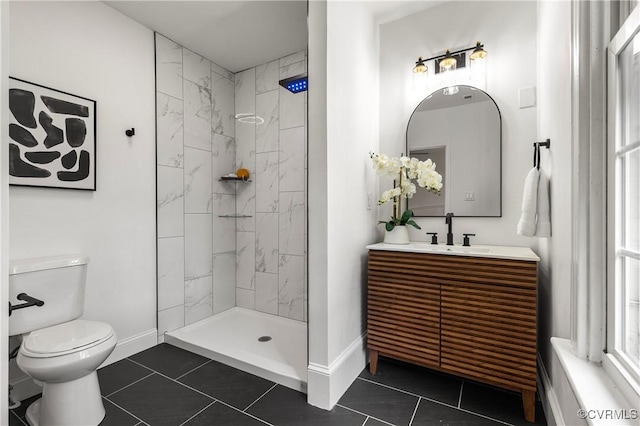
{"left": 9, "top": 255, "right": 89, "bottom": 336}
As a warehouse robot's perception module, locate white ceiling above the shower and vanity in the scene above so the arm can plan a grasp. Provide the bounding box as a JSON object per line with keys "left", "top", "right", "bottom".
{"left": 104, "top": 0, "right": 442, "bottom": 73}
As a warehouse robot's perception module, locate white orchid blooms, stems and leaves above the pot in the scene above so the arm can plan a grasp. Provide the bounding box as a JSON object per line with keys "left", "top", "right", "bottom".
{"left": 369, "top": 152, "right": 442, "bottom": 231}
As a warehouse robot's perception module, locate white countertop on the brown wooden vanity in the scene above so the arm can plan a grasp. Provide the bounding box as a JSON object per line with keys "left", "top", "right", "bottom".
{"left": 367, "top": 242, "right": 540, "bottom": 262}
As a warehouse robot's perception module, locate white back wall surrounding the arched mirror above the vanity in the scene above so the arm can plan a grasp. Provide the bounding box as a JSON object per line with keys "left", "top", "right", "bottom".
{"left": 378, "top": 1, "right": 540, "bottom": 249}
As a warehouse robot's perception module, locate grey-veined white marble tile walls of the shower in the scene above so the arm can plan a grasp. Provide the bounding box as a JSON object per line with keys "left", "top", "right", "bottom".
{"left": 156, "top": 34, "right": 307, "bottom": 386}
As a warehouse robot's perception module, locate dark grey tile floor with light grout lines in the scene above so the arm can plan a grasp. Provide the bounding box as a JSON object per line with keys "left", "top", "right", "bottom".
{"left": 9, "top": 344, "right": 546, "bottom": 426}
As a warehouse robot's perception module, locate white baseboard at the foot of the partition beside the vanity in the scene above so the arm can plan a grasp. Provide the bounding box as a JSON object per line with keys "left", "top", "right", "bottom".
{"left": 307, "top": 333, "right": 367, "bottom": 410}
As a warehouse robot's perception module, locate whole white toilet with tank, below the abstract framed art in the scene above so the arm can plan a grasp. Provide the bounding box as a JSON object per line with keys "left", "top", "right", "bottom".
{"left": 9, "top": 255, "right": 117, "bottom": 426}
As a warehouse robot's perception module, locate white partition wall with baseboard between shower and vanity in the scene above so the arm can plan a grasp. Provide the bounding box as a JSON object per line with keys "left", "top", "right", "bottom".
{"left": 308, "top": 1, "right": 378, "bottom": 408}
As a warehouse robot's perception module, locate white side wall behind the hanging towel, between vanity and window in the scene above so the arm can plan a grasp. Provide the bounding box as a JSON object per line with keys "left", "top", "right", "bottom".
{"left": 538, "top": 1, "right": 575, "bottom": 420}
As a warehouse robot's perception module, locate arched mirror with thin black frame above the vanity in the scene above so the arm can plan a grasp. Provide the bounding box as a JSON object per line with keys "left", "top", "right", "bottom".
{"left": 407, "top": 86, "right": 502, "bottom": 217}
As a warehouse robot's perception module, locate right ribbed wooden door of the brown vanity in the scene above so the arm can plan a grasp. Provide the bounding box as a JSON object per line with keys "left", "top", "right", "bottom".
{"left": 440, "top": 256, "right": 537, "bottom": 391}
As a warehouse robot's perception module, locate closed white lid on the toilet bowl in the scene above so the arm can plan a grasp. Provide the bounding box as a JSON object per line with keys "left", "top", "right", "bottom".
{"left": 22, "top": 320, "right": 113, "bottom": 355}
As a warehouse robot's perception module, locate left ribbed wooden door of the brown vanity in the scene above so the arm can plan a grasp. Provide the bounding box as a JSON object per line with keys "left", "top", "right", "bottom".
{"left": 367, "top": 250, "right": 440, "bottom": 367}
